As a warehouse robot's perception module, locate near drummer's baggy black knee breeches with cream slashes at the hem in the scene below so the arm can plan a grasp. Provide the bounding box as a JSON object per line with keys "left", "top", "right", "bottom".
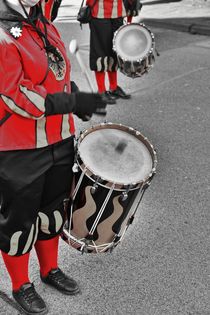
{"left": 0, "top": 137, "right": 74, "bottom": 256}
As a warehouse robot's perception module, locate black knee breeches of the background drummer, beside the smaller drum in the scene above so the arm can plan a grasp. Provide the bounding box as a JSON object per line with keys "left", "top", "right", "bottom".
{"left": 90, "top": 17, "right": 123, "bottom": 71}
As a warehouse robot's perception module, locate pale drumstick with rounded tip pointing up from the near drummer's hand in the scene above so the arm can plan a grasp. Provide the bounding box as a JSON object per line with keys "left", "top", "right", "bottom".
{"left": 69, "top": 39, "right": 106, "bottom": 116}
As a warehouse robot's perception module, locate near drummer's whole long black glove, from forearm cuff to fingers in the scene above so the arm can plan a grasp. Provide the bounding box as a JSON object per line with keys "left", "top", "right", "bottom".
{"left": 45, "top": 92, "right": 106, "bottom": 121}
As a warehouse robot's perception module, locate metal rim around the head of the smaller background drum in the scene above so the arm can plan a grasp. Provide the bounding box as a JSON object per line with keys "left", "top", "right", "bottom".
{"left": 112, "top": 23, "right": 155, "bottom": 62}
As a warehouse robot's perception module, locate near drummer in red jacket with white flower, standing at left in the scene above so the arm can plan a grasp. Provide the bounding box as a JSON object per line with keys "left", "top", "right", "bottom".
{"left": 0, "top": 0, "right": 106, "bottom": 314}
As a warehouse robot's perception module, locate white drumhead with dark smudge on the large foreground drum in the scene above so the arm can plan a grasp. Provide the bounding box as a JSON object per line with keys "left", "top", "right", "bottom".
{"left": 78, "top": 127, "right": 153, "bottom": 185}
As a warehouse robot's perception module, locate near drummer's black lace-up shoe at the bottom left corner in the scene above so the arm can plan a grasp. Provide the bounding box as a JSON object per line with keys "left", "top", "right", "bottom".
{"left": 12, "top": 283, "right": 48, "bottom": 315}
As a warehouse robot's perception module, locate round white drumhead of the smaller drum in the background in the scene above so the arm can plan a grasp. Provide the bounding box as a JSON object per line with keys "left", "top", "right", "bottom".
{"left": 114, "top": 24, "right": 153, "bottom": 61}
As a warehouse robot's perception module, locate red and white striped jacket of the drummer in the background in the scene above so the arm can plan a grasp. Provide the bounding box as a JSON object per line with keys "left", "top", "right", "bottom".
{"left": 86, "top": 0, "right": 126, "bottom": 19}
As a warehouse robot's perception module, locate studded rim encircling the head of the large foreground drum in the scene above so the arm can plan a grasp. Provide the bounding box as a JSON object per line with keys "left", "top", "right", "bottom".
{"left": 76, "top": 122, "right": 157, "bottom": 190}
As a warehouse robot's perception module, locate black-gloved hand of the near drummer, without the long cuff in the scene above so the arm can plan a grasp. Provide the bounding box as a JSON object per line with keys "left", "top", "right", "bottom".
{"left": 74, "top": 92, "right": 107, "bottom": 121}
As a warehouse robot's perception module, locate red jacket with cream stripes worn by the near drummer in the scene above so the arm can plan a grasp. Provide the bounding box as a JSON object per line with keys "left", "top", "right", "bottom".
{"left": 0, "top": 10, "right": 74, "bottom": 151}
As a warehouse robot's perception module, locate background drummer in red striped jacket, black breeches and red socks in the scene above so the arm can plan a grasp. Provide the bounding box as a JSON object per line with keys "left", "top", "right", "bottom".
{"left": 86, "top": 0, "right": 141, "bottom": 104}
